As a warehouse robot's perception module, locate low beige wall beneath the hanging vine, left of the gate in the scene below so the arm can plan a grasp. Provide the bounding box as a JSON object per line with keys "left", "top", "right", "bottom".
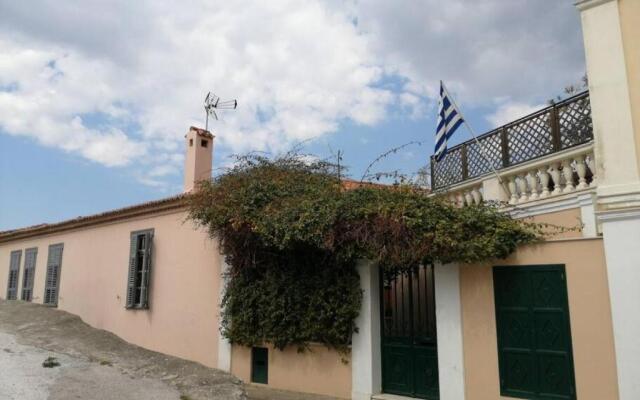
{"left": 231, "top": 345, "right": 351, "bottom": 398}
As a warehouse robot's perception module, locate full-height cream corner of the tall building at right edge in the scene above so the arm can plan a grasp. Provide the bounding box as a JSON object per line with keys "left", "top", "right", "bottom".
{"left": 576, "top": 0, "right": 640, "bottom": 400}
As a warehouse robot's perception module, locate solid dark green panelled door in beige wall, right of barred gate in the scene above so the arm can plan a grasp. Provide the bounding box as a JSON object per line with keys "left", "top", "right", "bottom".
{"left": 493, "top": 265, "right": 576, "bottom": 399}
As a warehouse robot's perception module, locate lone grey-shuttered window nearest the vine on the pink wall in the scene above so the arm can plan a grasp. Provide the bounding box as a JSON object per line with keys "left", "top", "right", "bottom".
{"left": 126, "top": 229, "right": 153, "bottom": 309}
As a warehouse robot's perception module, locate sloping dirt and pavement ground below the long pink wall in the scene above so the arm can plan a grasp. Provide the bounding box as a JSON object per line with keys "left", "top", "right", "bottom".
{"left": 0, "top": 300, "right": 247, "bottom": 400}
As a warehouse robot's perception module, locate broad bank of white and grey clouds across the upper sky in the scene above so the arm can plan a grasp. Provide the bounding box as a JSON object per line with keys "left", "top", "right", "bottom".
{"left": 0, "top": 0, "right": 583, "bottom": 186}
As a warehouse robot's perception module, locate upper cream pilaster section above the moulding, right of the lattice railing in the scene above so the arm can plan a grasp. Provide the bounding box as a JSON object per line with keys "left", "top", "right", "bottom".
{"left": 577, "top": 0, "right": 640, "bottom": 199}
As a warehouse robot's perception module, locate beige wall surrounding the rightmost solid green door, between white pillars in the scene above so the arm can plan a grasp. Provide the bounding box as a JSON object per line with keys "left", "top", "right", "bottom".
{"left": 460, "top": 238, "right": 618, "bottom": 400}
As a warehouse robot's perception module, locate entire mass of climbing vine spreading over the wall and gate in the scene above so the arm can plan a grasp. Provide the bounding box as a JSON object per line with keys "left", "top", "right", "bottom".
{"left": 190, "top": 155, "right": 542, "bottom": 351}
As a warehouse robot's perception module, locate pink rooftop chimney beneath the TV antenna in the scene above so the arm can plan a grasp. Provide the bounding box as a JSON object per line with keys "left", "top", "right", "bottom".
{"left": 183, "top": 126, "right": 214, "bottom": 193}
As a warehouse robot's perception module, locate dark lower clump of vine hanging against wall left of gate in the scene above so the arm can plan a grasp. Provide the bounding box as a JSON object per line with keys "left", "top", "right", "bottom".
{"left": 222, "top": 249, "right": 362, "bottom": 349}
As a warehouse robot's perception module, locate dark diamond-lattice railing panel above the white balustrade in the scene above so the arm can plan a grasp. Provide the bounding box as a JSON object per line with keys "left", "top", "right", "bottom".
{"left": 431, "top": 92, "right": 593, "bottom": 190}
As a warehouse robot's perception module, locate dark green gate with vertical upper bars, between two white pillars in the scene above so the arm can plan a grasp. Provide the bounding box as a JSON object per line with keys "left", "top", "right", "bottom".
{"left": 381, "top": 265, "right": 439, "bottom": 399}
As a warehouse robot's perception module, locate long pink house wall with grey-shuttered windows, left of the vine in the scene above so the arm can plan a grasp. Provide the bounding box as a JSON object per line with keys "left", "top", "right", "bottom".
{"left": 0, "top": 211, "right": 220, "bottom": 367}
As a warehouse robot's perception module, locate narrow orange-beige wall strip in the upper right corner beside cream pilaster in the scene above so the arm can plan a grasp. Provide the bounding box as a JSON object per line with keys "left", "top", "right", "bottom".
{"left": 618, "top": 0, "right": 640, "bottom": 177}
